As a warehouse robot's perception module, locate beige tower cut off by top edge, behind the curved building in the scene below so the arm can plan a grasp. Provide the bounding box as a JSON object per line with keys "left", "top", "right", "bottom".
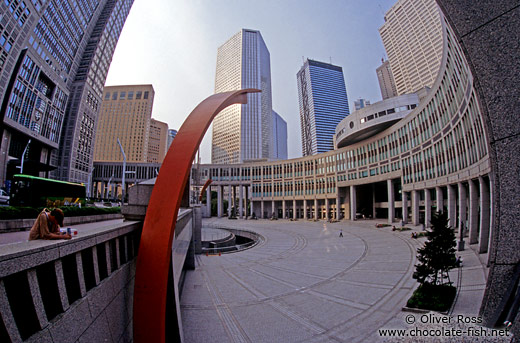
{"left": 379, "top": 0, "right": 442, "bottom": 95}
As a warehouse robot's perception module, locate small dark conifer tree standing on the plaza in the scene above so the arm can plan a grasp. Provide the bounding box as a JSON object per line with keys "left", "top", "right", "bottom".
{"left": 413, "top": 212, "right": 456, "bottom": 285}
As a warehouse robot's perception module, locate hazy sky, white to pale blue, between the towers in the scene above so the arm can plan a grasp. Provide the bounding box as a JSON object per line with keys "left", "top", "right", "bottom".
{"left": 106, "top": 0, "right": 396, "bottom": 163}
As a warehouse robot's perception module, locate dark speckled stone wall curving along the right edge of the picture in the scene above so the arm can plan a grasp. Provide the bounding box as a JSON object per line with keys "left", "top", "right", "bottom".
{"left": 437, "top": 0, "right": 520, "bottom": 335}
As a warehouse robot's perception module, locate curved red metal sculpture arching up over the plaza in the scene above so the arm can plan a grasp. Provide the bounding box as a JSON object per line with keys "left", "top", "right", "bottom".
{"left": 133, "top": 89, "right": 260, "bottom": 343}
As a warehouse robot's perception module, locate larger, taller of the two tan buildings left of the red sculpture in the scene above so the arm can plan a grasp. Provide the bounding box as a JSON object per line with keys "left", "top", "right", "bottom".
{"left": 94, "top": 85, "right": 155, "bottom": 162}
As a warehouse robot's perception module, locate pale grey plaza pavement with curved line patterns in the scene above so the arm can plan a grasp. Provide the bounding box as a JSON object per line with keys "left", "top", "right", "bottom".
{"left": 181, "top": 218, "right": 502, "bottom": 343}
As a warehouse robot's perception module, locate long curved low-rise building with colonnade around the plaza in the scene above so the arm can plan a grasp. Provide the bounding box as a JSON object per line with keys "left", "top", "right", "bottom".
{"left": 192, "top": 12, "right": 493, "bottom": 253}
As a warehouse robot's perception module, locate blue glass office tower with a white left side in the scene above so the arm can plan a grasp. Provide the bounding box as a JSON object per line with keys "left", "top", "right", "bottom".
{"left": 297, "top": 59, "right": 350, "bottom": 156}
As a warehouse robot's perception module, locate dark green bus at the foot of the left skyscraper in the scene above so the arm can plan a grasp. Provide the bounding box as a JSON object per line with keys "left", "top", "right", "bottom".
{"left": 9, "top": 174, "right": 86, "bottom": 207}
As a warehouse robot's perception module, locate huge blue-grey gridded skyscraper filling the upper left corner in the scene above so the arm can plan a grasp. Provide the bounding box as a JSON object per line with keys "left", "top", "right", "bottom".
{"left": 0, "top": 0, "right": 133, "bottom": 185}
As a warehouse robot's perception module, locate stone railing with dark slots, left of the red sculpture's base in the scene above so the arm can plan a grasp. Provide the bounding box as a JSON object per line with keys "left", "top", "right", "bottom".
{"left": 0, "top": 222, "right": 142, "bottom": 342}
